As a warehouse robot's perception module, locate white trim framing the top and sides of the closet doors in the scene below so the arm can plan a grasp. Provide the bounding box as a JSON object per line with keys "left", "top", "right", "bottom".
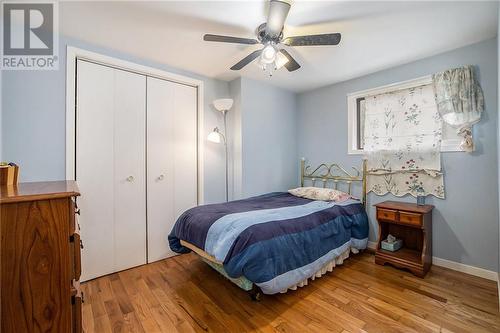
{"left": 66, "top": 46, "right": 204, "bottom": 204}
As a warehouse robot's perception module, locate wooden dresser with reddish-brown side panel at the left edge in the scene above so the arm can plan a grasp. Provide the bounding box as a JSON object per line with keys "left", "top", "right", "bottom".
{"left": 0, "top": 181, "right": 83, "bottom": 333}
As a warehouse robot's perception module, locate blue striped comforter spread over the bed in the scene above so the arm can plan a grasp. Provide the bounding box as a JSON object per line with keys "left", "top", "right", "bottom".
{"left": 168, "top": 192, "right": 368, "bottom": 294}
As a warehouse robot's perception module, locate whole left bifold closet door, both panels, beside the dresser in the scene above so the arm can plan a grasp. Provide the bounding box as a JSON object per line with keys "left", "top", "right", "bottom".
{"left": 75, "top": 60, "right": 146, "bottom": 280}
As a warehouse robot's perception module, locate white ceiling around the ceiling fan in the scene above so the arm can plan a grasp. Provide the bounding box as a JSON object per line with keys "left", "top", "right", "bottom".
{"left": 59, "top": 1, "right": 498, "bottom": 91}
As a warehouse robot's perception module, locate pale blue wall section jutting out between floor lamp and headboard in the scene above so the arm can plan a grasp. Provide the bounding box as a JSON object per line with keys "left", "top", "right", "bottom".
{"left": 229, "top": 78, "right": 299, "bottom": 198}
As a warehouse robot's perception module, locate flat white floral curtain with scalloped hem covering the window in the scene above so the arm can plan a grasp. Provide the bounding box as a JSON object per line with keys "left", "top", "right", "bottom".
{"left": 364, "top": 84, "right": 444, "bottom": 198}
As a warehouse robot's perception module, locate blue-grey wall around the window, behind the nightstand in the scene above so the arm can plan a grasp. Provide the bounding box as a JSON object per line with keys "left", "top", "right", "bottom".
{"left": 297, "top": 39, "right": 499, "bottom": 271}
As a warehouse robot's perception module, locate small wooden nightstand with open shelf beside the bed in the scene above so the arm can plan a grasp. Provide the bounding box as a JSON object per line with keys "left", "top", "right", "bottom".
{"left": 375, "top": 201, "right": 434, "bottom": 277}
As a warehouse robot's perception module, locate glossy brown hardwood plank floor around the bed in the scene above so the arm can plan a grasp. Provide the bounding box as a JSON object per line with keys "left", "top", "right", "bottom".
{"left": 83, "top": 253, "right": 500, "bottom": 333}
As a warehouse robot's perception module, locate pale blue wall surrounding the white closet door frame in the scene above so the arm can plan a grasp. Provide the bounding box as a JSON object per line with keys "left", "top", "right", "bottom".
{"left": 1, "top": 37, "right": 229, "bottom": 202}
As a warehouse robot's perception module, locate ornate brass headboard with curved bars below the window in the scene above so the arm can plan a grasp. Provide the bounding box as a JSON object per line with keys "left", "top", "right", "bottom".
{"left": 300, "top": 158, "right": 367, "bottom": 205}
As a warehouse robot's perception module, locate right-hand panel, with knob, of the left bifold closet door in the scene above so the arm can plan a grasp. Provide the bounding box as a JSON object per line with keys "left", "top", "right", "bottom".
{"left": 114, "top": 70, "right": 146, "bottom": 271}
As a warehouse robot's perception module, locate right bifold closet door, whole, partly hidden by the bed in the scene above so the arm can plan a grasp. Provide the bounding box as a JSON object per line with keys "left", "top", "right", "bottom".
{"left": 147, "top": 77, "right": 198, "bottom": 262}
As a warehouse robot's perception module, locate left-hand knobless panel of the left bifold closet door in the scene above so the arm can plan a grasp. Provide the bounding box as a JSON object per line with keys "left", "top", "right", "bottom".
{"left": 75, "top": 61, "right": 114, "bottom": 281}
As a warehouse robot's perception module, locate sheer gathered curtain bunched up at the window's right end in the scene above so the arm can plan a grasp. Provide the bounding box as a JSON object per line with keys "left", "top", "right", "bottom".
{"left": 432, "top": 65, "right": 484, "bottom": 152}
